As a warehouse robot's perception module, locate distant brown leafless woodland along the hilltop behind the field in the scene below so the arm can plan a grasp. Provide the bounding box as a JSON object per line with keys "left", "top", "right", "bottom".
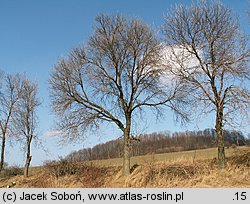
{"left": 67, "top": 129, "right": 249, "bottom": 161}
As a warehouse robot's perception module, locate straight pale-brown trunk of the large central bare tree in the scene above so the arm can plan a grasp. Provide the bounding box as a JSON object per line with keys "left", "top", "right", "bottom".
{"left": 123, "top": 117, "right": 131, "bottom": 176}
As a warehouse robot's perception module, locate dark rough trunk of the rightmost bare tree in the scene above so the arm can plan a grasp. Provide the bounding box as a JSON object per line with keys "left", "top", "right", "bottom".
{"left": 215, "top": 107, "right": 226, "bottom": 169}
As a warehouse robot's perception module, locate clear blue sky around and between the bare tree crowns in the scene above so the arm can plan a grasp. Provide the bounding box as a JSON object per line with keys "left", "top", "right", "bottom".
{"left": 0, "top": 0, "right": 250, "bottom": 165}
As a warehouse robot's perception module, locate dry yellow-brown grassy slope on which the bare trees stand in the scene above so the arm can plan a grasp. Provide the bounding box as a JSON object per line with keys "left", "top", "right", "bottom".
{"left": 0, "top": 147, "right": 250, "bottom": 188}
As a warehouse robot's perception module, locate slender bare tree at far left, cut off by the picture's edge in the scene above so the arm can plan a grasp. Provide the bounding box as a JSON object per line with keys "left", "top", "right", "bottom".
{"left": 0, "top": 74, "right": 22, "bottom": 171}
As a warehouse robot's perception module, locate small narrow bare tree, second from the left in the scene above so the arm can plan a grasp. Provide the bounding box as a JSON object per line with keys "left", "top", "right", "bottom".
{"left": 13, "top": 78, "right": 40, "bottom": 177}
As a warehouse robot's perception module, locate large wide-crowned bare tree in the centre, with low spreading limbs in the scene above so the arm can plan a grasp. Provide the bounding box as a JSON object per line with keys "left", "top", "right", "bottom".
{"left": 49, "top": 15, "right": 188, "bottom": 175}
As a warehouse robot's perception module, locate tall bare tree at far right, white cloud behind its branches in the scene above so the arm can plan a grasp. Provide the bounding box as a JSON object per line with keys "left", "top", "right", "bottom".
{"left": 163, "top": 1, "right": 250, "bottom": 168}
